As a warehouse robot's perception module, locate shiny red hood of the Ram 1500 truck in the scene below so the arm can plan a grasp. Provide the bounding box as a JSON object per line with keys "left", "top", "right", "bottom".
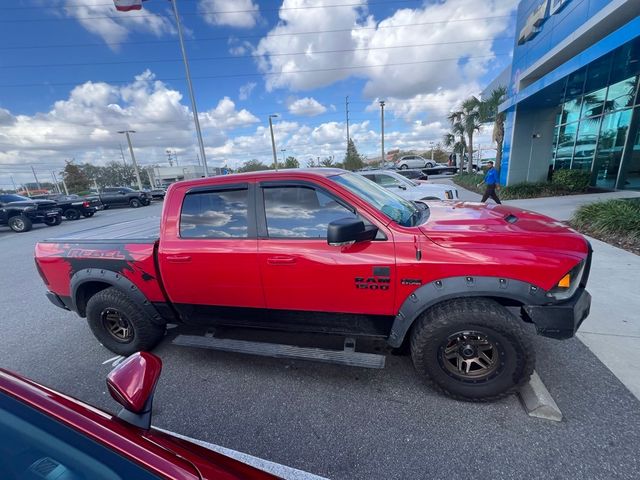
{"left": 420, "top": 202, "right": 588, "bottom": 254}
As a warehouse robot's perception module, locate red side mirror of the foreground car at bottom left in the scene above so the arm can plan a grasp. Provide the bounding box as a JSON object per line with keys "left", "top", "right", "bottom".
{"left": 107, "top": 352, "right": 162, "bottom": 430}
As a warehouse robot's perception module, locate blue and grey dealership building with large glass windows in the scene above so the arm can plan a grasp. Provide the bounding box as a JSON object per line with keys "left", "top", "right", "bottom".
{"left": 484, "top": 0, "right": 640, "bottom": 190}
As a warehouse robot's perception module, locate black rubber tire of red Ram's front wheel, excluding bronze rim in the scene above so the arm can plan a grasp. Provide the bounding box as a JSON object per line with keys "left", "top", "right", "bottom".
{"left": 410, "top": 298, "right": 535, "bottom": 402}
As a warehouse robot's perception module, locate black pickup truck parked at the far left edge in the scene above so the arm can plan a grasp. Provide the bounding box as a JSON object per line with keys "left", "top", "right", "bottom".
{"left": 0, "top": 194, "right": 62, "bottom": 233}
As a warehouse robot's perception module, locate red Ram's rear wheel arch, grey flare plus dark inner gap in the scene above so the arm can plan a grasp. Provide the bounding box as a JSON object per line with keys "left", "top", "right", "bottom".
{"left": 71, "top": 268, "right": 167, "bottom": 325}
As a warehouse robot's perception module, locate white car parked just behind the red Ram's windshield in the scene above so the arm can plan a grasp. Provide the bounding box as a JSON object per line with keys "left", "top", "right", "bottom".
{"left": 357, "top": 170, "right": 458, "bottom": 201}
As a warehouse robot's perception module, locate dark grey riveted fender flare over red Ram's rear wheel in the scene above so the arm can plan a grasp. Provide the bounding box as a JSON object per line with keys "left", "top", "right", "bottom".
{"left": 70, "top": 268, "right": 167, "bottom": 325}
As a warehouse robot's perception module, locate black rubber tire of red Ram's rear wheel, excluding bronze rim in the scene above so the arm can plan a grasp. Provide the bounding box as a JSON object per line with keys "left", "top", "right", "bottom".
{"left": 87, "top": 287, "right": 166, "bottom": 356}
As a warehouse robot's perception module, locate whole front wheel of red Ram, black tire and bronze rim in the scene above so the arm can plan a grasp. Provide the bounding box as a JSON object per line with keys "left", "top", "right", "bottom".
{"left": 411, "top": 298, "right": 535, "bottom": 402}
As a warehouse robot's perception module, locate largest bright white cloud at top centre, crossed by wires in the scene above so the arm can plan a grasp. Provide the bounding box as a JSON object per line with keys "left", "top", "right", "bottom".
{"left": 256, "top": 0, "right": 518, "bottom": 98}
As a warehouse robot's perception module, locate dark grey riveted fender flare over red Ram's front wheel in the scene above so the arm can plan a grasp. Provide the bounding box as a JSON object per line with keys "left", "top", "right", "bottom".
{"left": 387, "top": 276, "right": 552, "bottom": 348}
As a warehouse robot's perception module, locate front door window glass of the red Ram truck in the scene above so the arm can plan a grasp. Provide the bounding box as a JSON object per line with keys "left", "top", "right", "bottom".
{"left": 263, "top": 187, "right": 357, "bottom": 238}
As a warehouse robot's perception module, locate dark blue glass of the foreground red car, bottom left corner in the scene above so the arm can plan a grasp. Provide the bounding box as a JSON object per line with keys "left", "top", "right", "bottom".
{"left": 0, "top": 394, "right": 158, "bottom": 480}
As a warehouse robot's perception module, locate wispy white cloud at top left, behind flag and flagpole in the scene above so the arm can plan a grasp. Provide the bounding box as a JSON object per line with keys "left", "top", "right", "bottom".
{"left": 57, "top": 0, "right": 176, "bottom": 50}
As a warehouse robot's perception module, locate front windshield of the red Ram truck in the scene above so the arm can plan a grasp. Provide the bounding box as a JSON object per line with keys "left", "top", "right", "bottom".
{"left": 330, "top": 173, "right": 422, "bottom": 227}
